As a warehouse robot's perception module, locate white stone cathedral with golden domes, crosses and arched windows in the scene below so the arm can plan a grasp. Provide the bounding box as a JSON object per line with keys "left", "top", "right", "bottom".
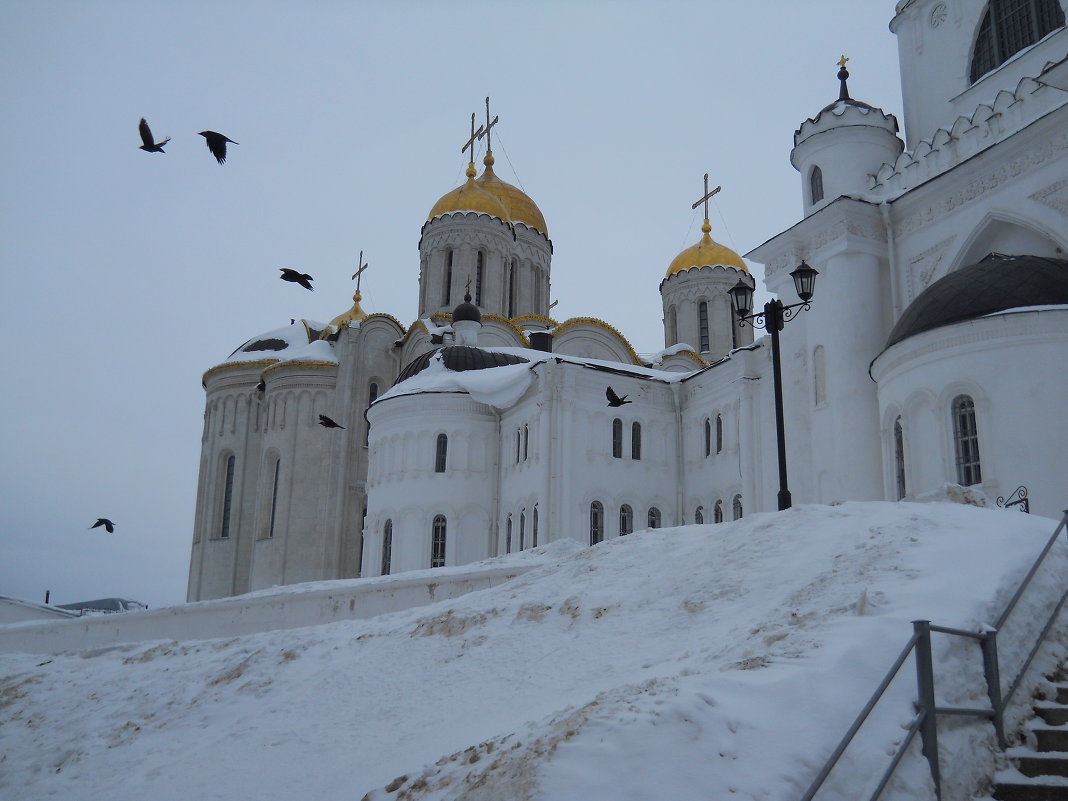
{"left": 188, "top": 0, "right": 1068, "bottom": 600}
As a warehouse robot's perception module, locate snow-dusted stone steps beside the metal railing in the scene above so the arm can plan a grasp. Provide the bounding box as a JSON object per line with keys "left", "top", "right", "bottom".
{"left": 993, "top": 673, "right": 1068, "bottom": 801}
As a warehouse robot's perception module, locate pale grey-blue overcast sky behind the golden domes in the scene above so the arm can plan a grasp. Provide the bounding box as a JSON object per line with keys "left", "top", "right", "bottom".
{"left": 0, "top": 0, "right": 901, "bottom": 607}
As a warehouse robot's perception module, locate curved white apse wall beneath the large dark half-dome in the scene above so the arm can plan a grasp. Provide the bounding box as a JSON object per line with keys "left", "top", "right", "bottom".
{"left": 873, "top": 309, "right": 1068, "bottom": 517}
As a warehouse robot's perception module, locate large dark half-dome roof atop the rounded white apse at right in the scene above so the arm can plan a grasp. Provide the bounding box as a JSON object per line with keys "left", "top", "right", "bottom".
{"left": 886, "top": 253, "right": 1068, "bottom": 347}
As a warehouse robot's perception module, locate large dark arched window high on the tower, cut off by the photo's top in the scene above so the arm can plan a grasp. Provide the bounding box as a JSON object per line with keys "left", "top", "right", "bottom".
{"left": 971, "top": 0, "right": 1065, "bottom": 83}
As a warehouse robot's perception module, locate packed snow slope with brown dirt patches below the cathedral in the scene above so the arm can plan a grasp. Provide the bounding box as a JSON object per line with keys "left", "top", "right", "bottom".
{"left": 0, "top": 503, "right": 1068, "bottom": 801}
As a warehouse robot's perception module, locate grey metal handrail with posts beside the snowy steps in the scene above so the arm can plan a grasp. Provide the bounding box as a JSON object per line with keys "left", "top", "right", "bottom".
{"left": 801, "top": 509, "right": 1068, "bottom": 801}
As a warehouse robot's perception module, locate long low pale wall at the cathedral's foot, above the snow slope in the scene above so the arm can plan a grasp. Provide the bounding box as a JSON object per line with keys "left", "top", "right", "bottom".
{"left": 0, "top": 545, "right": 551, "bottom": 654}
